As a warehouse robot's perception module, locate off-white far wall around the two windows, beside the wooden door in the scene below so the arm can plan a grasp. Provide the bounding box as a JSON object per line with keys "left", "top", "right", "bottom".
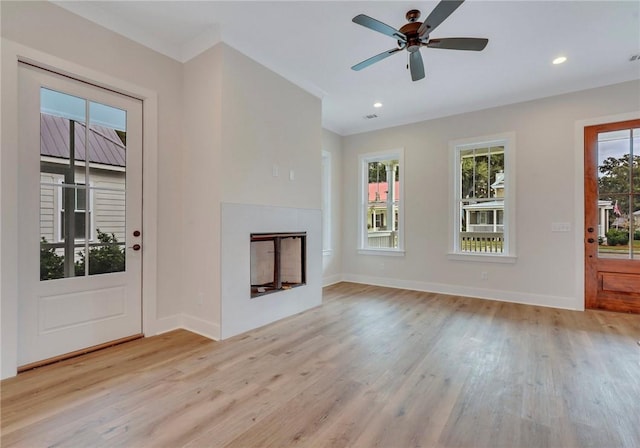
{"left": 342, "top": 82, "right": 640, "bottom": 309}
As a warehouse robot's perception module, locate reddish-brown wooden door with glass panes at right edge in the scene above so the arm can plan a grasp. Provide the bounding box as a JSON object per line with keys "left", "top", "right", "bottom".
{"left": 584, "top": 120, "right": 640, "bottom": 313}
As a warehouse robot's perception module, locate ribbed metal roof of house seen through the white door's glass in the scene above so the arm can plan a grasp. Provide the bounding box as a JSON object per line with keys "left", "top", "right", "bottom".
{"left": 40, "top": 113, "right": 127, "bottom": 167}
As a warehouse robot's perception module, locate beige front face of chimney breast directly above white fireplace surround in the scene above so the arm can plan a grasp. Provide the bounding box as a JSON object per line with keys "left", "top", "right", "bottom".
{"left": 220, "top": 44, "right": 322, "bottom": 209}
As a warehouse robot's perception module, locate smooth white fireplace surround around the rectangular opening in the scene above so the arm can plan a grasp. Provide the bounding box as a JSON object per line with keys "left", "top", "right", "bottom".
{"left": 220, "top": 203, "right": 322, "bottom": 339}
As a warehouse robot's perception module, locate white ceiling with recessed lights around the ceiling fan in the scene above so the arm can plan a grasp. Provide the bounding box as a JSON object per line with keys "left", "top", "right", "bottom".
{"left": 55, "top": 0, "right": 640, "bottom": 135}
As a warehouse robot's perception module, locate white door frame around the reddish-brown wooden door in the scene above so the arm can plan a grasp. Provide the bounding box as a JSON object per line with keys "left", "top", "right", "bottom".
{"left": 574, "top": 111, "right": 640, "bottom": 311}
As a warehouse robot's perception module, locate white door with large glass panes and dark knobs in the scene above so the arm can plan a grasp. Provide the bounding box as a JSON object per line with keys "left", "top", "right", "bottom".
{"left": 18, "top": 64, "right": 142, "bottom": 367}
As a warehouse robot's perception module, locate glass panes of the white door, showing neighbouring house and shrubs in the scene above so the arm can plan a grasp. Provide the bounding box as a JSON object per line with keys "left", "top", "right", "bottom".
{"left": 40, "top": 87, "right": 127, "bottom": 280}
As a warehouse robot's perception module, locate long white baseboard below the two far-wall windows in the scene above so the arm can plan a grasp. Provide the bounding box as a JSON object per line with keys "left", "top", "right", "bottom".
{"left": 342, "top": 274, "right": 583, "bottom": 311}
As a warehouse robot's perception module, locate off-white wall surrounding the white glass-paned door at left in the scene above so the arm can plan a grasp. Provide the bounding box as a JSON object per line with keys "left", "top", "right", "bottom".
{"left": 0, "top": 1, "right": 182, "bottom": 377}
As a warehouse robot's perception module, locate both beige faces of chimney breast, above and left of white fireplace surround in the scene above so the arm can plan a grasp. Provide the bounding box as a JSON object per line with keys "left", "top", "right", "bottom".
{"left": 181, "top": 44, "right": 322, "bottom": 338}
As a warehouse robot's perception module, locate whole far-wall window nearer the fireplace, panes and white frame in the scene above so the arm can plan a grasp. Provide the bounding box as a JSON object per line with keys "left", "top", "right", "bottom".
{"left": 359, "top": 150, "right": 403, "bottom": 253}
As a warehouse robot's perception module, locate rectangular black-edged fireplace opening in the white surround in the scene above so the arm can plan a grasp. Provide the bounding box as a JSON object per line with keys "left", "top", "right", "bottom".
{"left": 251, "top": 232, "right": 307, "bottom": 298}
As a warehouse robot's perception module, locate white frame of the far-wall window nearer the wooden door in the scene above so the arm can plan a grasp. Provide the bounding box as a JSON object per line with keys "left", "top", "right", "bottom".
{"left": 448, "top": 132, "right": 517, "bottom": 263}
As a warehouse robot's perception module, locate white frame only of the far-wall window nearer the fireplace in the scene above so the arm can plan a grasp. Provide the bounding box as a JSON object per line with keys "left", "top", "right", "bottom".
{"left": 358, "top": 148, "right": 405, "bottom": 256}
